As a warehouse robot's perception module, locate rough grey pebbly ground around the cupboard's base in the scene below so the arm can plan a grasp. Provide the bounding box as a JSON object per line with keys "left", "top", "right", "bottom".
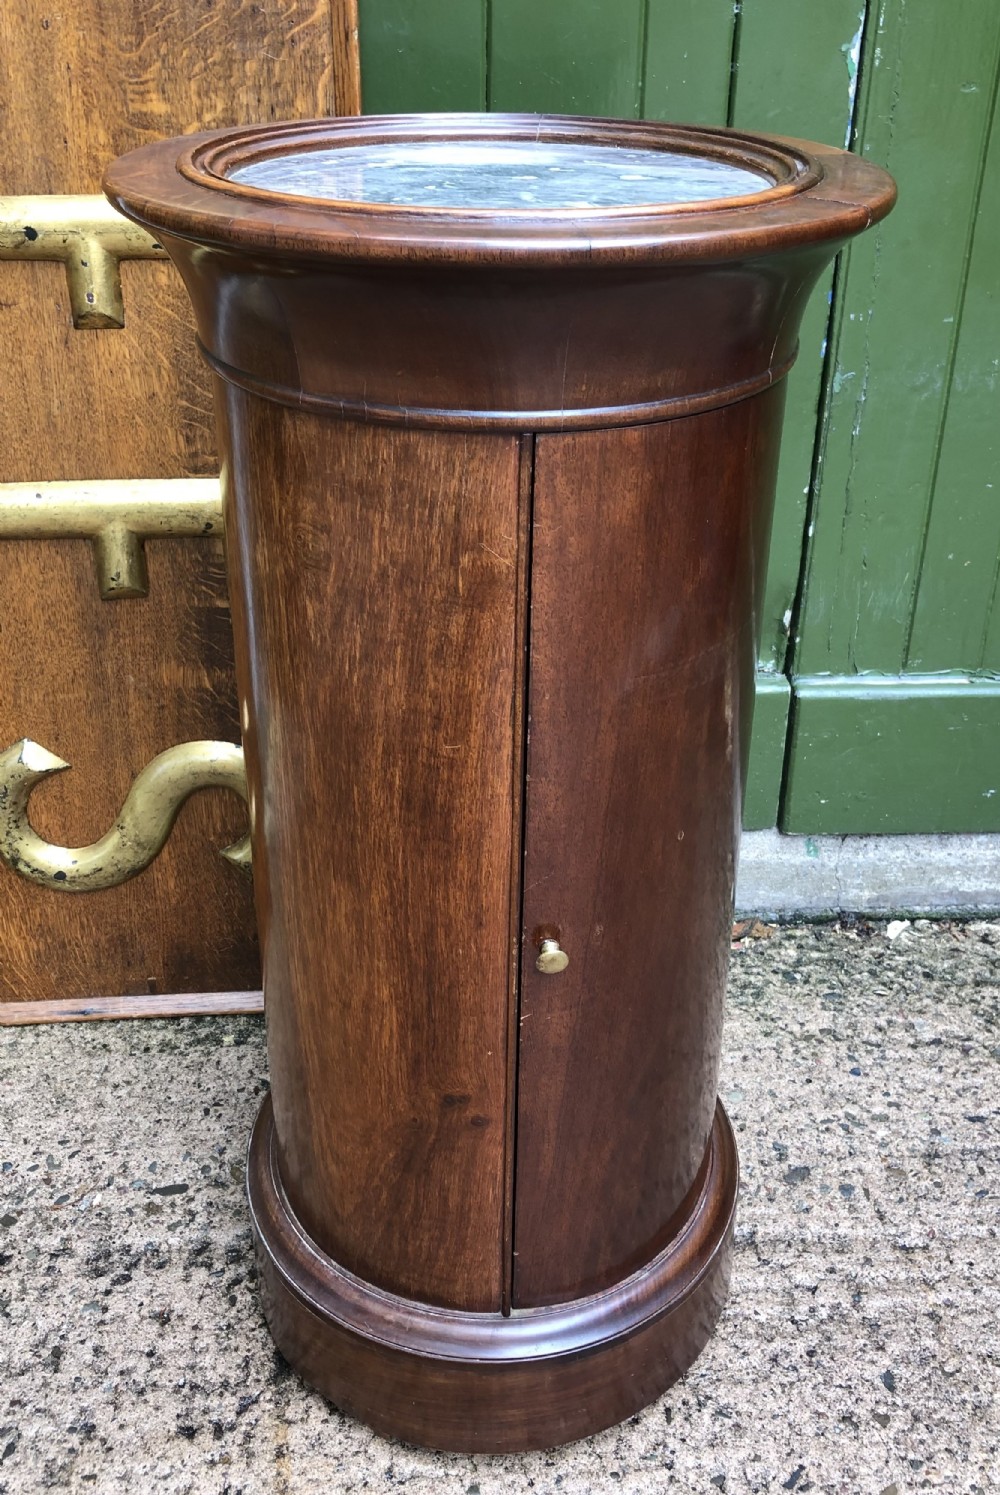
{"left": 0, "top": 921, "right": 1000, "bottom": 1495}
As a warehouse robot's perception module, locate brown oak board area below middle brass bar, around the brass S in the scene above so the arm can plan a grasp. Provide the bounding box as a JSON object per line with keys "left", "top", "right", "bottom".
{"left": 0, "top": 540, "right": 260, "bottom": 1002}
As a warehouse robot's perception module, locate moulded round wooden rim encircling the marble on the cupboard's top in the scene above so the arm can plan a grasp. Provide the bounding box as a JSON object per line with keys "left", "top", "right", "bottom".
{"left": 105, "top": 114, "right": 895, "bottom": 266}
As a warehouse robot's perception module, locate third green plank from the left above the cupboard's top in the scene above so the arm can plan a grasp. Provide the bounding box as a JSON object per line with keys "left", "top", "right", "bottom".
{"left": 641, "top": 0, "right": 735, "bottom": 124}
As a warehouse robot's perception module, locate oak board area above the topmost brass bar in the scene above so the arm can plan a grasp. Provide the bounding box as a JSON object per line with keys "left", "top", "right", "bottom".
{"left": 0, "top": 0, "right": 344, "bottom": 193}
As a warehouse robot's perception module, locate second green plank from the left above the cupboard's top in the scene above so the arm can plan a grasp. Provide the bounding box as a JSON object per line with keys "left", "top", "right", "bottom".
{"left": 489, "top": 0, "right": 644, "bottom": 118}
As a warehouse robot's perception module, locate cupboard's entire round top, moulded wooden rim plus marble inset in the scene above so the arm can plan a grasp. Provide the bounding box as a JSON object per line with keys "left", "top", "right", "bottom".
{"left": 105, "top": 114, "right": 895, "bottom": 263}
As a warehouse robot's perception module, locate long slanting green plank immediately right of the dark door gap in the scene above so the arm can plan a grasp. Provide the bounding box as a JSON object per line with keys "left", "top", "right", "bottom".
{"left": 795, "top": 0, "right": 1000, "bottom": 676}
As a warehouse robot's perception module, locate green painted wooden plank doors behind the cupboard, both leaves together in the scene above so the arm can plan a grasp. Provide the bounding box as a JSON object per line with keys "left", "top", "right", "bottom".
{"left": 360, "top": 0, "right": 1000, "bottom": 833}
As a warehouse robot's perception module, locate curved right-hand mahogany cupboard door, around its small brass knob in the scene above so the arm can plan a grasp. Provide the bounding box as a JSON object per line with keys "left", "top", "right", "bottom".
{"left": 514, "top": 390, "right": 782, "bottom": 1307}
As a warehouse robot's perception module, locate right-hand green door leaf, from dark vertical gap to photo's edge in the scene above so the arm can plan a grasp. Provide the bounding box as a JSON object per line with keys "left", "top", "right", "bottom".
{"left": 779, "top": 0, "right": 1000, "bottom": 833}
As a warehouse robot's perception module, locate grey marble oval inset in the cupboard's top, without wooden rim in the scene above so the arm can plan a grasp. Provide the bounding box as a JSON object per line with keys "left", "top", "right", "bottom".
{"left": 229, "top": 141, "right": 774, "bottom": 212}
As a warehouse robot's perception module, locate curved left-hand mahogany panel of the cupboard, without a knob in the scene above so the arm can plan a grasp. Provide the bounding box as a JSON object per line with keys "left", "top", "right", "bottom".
{"left": 216, "top": 387, "right": 523, "bottom": 1308}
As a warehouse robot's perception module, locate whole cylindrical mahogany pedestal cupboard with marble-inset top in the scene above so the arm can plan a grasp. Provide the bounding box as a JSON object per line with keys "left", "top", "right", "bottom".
{"left": 106, "top": 115, "right": 892, "bottom": 1452}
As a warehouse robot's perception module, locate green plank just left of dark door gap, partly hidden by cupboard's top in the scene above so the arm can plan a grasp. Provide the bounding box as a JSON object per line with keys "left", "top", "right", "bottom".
{"left": 732, "top": 0, "right": 864, "bottom": 670}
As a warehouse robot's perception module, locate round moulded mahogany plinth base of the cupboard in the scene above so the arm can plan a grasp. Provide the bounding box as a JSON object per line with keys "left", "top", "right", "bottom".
{"left": 248, "top": 1096, "right": 738, "bottom": 1453}
